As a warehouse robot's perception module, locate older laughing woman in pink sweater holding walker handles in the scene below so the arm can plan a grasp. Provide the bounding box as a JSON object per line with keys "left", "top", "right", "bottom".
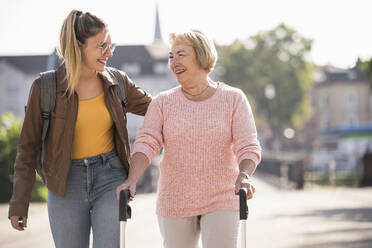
{"left": 117, "top": 30, "right": 261, "bottom": 248}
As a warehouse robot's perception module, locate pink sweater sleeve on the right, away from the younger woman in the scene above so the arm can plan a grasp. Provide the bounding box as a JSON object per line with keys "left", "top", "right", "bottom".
{"left": 232, "top": 90, "right": 261, "bottom": 166}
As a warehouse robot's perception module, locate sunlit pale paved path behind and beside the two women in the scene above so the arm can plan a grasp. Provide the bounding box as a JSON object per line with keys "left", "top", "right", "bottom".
{"left": 0, "top": 173, "right": 372, "bottom": 248}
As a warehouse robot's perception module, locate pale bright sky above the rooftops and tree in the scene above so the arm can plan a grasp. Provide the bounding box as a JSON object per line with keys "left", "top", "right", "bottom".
{"left": 0, "top": 0, "right": 372, "bottom": 68}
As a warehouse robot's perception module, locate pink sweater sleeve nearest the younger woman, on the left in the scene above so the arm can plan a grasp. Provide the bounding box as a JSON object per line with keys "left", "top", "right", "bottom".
{"left": 133, "top": 97, "right": 164, "bottom": 162}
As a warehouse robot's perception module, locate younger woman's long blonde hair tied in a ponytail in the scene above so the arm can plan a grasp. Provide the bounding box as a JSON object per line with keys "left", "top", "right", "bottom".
{"left": 58, "top": 10, "right": 107, "bottom": 97}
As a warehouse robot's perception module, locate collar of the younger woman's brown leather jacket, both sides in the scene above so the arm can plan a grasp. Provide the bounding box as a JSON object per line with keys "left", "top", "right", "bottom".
{"left": 56, "top": 63, "right": 118, "bottom": 92}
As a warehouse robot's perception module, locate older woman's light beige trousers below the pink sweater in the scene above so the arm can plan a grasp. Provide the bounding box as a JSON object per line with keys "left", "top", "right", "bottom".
{"left": 158, "top": 211, "right": 239, "bottom": 248}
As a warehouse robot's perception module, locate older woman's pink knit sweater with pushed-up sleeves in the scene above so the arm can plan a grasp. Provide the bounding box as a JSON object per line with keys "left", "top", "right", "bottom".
{"left": 133, "top": 83, "right": 261, "bottom": 218}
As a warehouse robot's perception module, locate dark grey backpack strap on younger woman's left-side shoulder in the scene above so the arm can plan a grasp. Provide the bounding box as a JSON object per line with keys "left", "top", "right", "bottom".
{"left": 40, "top": 70, "right": 57, "bottom": 142}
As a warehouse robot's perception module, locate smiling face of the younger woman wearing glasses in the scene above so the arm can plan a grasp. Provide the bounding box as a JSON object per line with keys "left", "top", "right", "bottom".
{"left": 81, "top": 28, "right": 112, "bottom": 72}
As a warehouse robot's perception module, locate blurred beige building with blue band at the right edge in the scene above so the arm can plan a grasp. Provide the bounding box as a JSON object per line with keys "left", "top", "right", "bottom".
{"left": 308, "top": 59, "right": 372, "bottom": 169}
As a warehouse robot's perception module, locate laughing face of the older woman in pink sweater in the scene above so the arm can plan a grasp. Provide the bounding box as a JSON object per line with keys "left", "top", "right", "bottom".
{"left": 169, "top": 44, "right": 206, "bottom": 83}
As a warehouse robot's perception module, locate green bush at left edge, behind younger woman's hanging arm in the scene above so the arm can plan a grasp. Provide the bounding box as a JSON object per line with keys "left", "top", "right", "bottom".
{"left": 0, "top": 113, "right": 47, "bottom": 202}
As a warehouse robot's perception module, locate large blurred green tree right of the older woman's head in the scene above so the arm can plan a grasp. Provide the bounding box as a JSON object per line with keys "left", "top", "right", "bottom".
{"left": 219, "top": 24, "right": 313, "bottom": 148}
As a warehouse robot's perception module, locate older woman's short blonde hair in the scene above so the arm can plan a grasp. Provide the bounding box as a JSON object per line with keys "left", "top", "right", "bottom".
{"left": 169, "top": 29, "right": 218, "bottom": 73}
